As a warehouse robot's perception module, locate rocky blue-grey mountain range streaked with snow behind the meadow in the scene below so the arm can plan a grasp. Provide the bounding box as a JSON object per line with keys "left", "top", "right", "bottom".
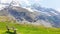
{"left": 0, "top": 2, "right": 60, "bottom": 27}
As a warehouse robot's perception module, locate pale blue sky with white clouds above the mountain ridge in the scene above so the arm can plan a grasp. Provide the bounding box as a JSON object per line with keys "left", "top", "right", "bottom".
{"left": 0, "top": 0, "right": 60, "bottom": 11}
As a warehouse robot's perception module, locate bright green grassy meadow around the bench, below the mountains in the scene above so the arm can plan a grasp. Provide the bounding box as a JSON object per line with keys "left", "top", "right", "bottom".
{"left": 0, "top": 22, "right": 60, "bottom": 34}
